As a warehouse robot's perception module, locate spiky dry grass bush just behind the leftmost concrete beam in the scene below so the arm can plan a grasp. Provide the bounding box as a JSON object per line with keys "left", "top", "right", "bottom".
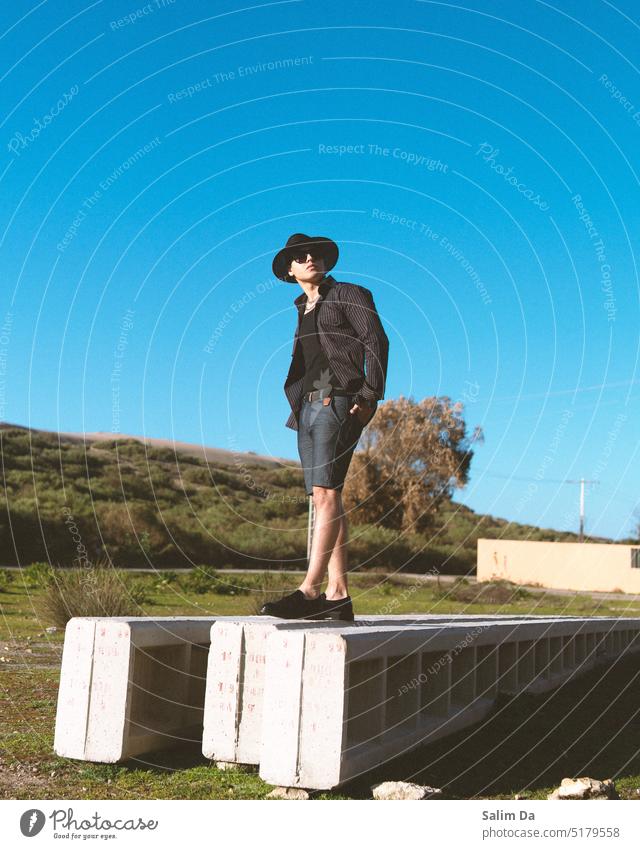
{"left": 36, "top": 559, "right": 141, "bottom": 628}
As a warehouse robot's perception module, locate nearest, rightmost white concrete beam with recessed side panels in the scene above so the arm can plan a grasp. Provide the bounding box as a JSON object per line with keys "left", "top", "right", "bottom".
{"left": 260, "top": 618, "right": 640, "bottom": 789}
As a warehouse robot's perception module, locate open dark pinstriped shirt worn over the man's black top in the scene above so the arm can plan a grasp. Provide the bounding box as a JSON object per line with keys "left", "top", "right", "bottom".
{"left": 284, "top": 274, "right": 389, "bottom": 430}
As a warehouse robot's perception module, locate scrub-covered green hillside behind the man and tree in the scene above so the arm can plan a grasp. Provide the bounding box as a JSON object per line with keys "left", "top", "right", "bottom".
{"left": 0, "top": 425, "right": 620, "bottom": 574}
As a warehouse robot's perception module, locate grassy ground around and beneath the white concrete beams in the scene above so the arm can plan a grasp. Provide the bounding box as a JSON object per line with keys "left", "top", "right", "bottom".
{"left": 0, "top": 575, "right": 640, "bottom": 799}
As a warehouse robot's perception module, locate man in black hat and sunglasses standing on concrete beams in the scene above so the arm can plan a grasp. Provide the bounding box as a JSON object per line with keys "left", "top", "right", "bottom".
{"left": 260, "top": 233, "right": 389, "bottom": 622}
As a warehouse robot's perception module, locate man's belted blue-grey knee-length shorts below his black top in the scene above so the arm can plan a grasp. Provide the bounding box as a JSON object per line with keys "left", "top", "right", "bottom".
{"left": 298, "top": 394, "right": 364, "bottom": 495}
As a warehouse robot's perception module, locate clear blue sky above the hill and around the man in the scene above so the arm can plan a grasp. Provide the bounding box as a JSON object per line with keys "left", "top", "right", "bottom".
{"left": 0, "top": 0, "right": 640, "bottom": 539}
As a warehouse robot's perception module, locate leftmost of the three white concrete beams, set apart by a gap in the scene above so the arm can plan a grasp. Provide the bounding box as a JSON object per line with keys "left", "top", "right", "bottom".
{"left": 54, "top": 616, "right": 268, "bottom": 763}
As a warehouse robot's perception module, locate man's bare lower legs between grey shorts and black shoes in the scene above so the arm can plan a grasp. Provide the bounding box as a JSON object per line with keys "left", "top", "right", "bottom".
{"left": 299, "top": 486, "right": 347, "bottom": 598}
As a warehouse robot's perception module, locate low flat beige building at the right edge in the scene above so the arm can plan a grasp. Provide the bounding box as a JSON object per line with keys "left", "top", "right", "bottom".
{"left": 477, "top": 539, "right": 640, "bottom": 593}
